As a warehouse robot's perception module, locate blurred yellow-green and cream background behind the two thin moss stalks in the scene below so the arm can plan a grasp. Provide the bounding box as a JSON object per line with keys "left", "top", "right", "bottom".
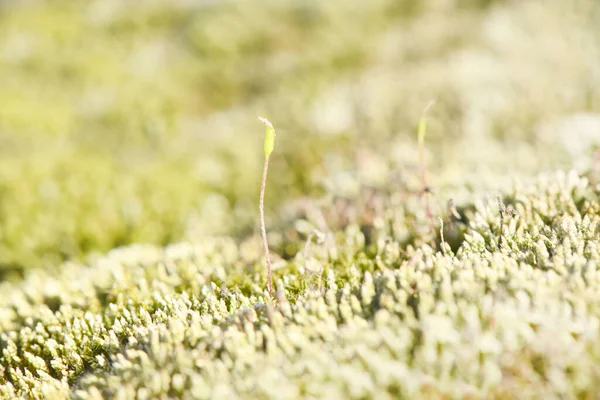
{"left": 0, "top": 0, "right": 600, "bottom": 278}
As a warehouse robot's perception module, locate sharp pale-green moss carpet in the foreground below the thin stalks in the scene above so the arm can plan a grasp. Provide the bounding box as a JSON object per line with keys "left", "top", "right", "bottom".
{"left": 0, "top": 170, "right": 600, "bottom": 398}
